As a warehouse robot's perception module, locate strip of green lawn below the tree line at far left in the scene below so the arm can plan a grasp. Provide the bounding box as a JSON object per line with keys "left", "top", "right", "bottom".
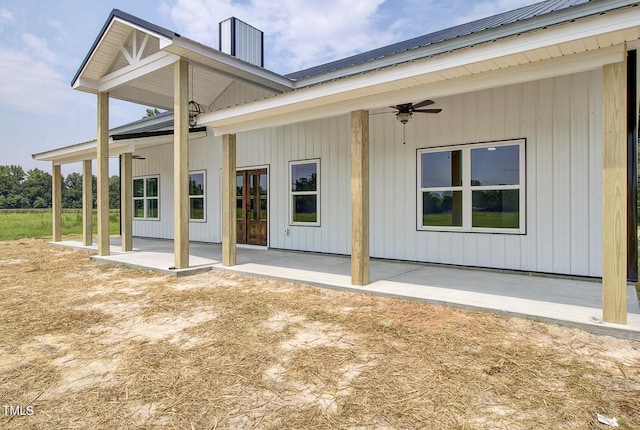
{"left": 0, "top": 209, "right": 120, "bottom": 241}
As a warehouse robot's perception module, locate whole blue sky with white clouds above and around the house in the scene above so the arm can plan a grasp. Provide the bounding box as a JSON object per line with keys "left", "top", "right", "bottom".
{"left": 0, "top": 0, "right": 538, "bottom": 175}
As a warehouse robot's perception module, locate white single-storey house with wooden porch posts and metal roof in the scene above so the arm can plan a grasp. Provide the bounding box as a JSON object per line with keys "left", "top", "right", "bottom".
{"left": 34, "top": 0, "right": 640, "bottom": 323}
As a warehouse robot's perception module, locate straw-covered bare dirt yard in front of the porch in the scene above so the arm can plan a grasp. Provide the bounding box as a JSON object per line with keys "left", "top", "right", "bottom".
{"left": 0, "top": 240, "right": 640, "bottom": 429}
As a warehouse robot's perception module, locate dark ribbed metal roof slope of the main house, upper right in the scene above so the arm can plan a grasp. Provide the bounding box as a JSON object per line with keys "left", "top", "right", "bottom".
{"left": 285, "top": 0, "right": 596, "bottom": 80}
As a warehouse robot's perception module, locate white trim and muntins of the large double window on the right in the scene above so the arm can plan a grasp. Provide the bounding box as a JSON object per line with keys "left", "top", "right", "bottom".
{"left": 416, "top": 139, "right": 527, "bottom": 234}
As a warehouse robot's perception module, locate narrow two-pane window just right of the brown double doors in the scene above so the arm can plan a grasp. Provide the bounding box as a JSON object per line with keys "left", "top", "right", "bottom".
{"left": 289, "top": 160, "right": 320, "bottom": 226}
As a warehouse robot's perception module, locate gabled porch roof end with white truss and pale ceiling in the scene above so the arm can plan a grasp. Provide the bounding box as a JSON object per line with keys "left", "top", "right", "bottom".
{"left": 72, "top": 11, "right": 290, "bottom": 109}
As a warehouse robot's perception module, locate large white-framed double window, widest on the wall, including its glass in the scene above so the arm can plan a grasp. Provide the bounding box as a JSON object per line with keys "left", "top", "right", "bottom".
{"left": 418, "top": 139, "right": 525, "bottom": 233}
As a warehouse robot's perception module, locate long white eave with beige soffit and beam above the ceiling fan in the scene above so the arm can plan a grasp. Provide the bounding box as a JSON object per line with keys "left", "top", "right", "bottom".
{"left": 198, "top": 7, "right": 640, "bottom": 135}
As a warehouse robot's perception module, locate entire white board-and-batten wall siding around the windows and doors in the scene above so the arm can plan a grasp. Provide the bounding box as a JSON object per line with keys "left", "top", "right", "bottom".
{"left": 134, "top": 70, "right": 602, "bottom": 276}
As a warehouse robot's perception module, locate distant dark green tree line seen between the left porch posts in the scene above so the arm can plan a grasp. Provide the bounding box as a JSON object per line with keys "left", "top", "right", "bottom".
{"left": 0, "top": 165, "right": 120, "bottom": 209}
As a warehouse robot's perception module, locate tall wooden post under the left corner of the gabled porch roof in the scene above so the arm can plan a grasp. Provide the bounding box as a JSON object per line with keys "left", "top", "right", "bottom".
{"left": 97, "top": 93, "right": 109, "bottom": 255}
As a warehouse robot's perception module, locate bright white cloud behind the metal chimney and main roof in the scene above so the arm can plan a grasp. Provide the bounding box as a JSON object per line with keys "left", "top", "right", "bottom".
{"left": 163, "top": 0, "right": 395, "bottom": 73}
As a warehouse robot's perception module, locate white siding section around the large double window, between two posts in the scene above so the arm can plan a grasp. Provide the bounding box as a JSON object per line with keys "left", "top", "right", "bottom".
{"left": 368, "top": 71, "right": 602, "bottom": 276}
